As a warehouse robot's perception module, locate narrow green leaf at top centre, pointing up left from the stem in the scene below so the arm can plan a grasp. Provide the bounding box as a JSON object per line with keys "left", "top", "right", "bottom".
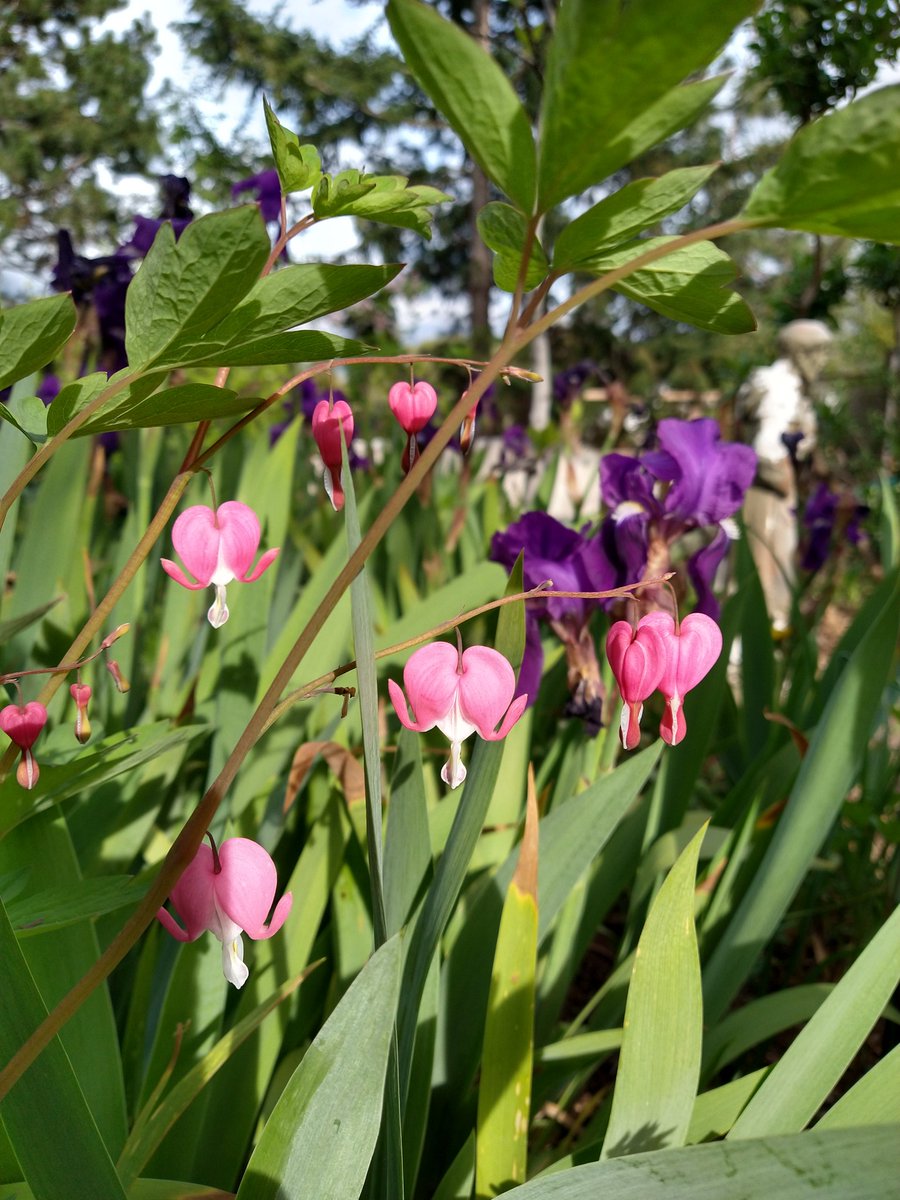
{"left": 388, "top": 0, "right": 535, "bottom": 212}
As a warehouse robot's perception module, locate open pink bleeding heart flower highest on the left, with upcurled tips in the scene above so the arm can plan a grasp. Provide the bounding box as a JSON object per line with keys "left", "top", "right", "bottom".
{"left": 160, "top": 500, "right": 278, "bottom": 629}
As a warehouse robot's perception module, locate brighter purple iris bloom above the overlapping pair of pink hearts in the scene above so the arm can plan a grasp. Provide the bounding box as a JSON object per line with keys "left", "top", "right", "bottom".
{"left": 600, "top": 418, "right": 756, "bottom": 619}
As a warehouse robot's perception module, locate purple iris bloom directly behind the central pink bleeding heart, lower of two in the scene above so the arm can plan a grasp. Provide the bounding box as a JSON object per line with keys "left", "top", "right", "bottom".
{"left": 491, "top": 512, "right": 616, "bottom": 733}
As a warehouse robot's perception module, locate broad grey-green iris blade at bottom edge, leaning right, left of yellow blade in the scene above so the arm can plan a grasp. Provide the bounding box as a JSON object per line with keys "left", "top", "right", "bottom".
{"left": 238, "top": 936, "right": 402, "bottom": 1200}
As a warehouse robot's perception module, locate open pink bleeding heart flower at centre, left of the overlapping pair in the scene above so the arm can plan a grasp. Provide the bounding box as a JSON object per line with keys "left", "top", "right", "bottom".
{"left": 388, "top": 642, "right": 528, "bottom": 787}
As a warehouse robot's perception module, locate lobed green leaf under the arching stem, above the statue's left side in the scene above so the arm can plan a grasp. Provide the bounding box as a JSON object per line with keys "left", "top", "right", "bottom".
{"left": 582, "top": 238, "right": 756, "bottom": 334}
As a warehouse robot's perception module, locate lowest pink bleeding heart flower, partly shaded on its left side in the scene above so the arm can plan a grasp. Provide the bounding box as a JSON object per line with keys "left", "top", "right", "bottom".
{"left": 156, "top": 838, "right": 293, "bottom": 988}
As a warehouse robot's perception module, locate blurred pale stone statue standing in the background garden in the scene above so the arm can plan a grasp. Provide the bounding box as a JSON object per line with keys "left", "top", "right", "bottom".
{"left": 737, "top": 320, "right": 832, "bottom": 635}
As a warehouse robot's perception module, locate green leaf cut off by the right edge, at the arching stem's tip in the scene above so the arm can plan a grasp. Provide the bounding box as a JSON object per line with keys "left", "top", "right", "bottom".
{"left": 740, "top": 84, "right": 900, "bottom": 244}
